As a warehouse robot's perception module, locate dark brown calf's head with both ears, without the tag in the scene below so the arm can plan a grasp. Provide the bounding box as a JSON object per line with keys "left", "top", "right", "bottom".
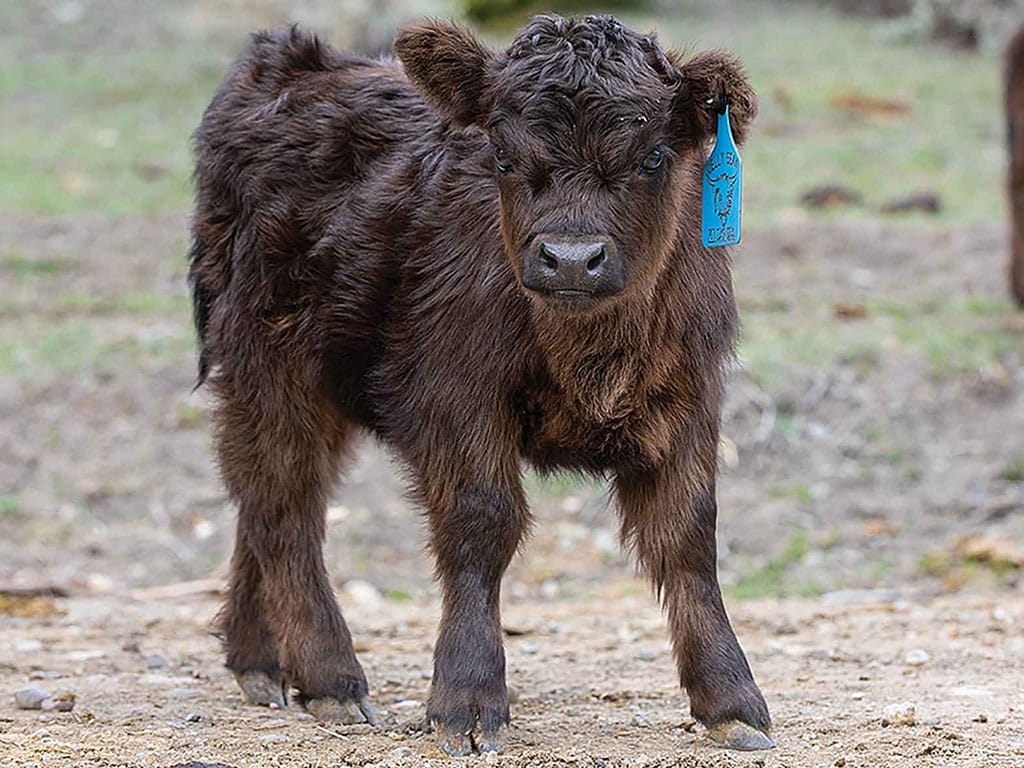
{"left": 395, "top": 16, "right": 757, "bottom": 311}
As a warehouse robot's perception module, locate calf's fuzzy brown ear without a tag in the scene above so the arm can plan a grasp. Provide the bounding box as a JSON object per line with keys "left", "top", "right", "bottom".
{"left": 394, "top": 19, "right": 496, "bottom": 126}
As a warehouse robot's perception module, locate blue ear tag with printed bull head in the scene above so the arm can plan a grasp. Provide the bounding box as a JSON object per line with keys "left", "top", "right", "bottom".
{"left": 700, "top": 104, "right": 743, "bottom": 248}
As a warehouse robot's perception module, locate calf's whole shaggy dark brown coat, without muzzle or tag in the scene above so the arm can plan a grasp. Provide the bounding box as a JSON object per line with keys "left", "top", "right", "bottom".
{"left": 190, "top": 16, "right": 770, "bottom": 751}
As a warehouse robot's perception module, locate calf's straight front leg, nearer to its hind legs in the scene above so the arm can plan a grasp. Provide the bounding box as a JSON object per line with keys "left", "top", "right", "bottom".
{"left": 427, "top": 483, "right": 528, "bottom": 756}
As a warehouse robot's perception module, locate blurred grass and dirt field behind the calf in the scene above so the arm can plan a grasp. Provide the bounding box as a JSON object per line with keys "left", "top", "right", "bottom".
{"left": 0, "top": 0, "right": 1024, "bottom": 614}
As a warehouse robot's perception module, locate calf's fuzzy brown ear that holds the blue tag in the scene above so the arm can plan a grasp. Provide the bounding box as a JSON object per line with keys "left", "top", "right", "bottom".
{"left": 673, "top": 50, "right": 758, "bottom": 145}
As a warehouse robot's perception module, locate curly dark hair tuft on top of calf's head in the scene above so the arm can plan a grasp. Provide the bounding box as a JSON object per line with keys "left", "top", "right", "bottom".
{"left": 505, "top": 15, "right": 673, "bottom": 90}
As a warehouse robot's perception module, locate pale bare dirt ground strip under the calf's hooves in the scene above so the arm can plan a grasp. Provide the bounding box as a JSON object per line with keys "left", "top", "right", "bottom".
{"left": 0, "top": 594, "right": 1024, "bottom": 768}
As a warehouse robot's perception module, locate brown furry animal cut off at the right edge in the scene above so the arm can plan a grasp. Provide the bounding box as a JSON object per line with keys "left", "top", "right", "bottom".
{"left": 1007, "top": 27, "right": 1024, "bottom": 306}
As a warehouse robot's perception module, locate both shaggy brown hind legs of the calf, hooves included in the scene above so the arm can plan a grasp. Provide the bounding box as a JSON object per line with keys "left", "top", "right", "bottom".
{"left": 215, "top": 365, "right": 373, "bottom": 722}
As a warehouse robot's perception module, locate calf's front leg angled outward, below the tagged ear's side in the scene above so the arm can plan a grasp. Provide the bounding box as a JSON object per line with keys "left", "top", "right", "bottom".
{"left": 616, "top": 442, "right": 774, "bottom": 750}
